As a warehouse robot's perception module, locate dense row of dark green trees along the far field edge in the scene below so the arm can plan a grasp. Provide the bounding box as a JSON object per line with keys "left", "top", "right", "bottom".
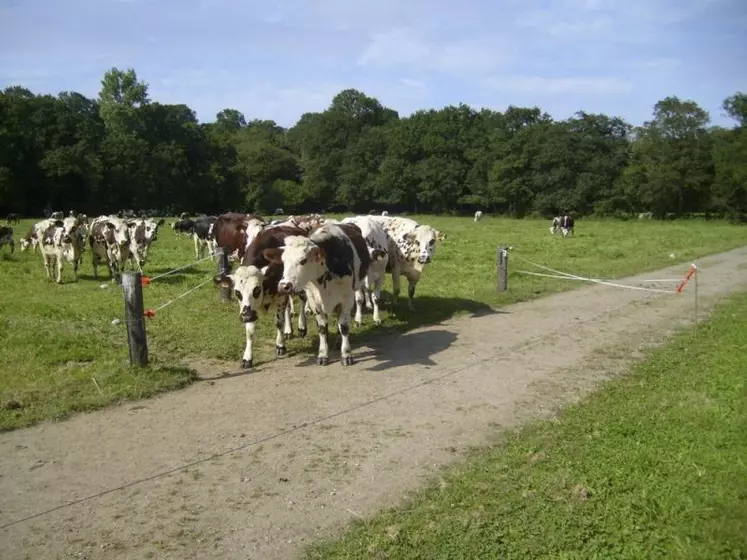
{"left": 0, "top": 68, "right": 747, "bottom": 220}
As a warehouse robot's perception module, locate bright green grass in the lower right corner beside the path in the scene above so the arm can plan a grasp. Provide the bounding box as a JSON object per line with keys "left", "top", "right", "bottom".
{"left": 307, "top": 288, "right": 747, "bottom": 560}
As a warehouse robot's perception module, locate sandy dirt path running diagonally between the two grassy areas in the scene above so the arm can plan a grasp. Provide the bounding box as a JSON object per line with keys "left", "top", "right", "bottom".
{"left": 0, "top": 247, "right": 747, "bottom": 560}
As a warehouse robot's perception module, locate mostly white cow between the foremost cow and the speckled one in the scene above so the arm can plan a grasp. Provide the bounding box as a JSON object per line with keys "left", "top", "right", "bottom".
{"left": 342, "top": 216, "right": 389, "bottom": 326}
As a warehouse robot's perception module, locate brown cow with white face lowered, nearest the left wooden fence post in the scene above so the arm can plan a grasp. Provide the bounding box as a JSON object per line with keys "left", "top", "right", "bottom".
{"left": 215, "top": 226, "right": 306, "bottom": 369}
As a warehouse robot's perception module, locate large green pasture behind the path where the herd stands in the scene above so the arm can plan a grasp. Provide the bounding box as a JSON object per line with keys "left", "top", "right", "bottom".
{"left": 0, "top": 216, "right": 747, "bottom": 429}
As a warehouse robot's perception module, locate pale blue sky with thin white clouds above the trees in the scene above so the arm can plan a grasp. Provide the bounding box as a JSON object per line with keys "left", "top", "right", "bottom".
{"left": 0, "top": 0, "right": 747, "bottom": 126}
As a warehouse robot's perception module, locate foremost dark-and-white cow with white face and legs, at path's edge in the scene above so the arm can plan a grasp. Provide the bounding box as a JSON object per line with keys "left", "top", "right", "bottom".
{"left": 264, "top": 223, "right": 371, "bottom": 366}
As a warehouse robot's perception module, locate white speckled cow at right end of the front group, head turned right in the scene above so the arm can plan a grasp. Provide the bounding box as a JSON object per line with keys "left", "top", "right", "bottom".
{"left": 373, "top": 216, "right": 446, "bottom": 310}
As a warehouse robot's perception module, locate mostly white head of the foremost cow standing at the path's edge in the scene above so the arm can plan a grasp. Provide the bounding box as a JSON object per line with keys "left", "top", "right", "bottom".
{"left": 263, "top": 235, "right": 325, "bottom": 294}
